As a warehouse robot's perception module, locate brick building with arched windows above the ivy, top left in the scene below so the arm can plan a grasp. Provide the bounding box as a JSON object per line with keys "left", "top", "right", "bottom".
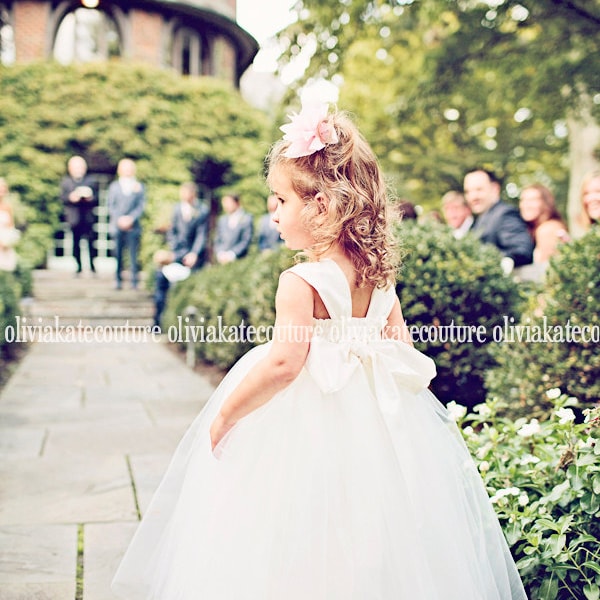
{"left": 0, "top": 0, "right": 258, "bottom": 87}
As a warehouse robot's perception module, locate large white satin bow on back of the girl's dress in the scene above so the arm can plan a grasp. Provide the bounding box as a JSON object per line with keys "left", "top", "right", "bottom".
{"left": 306, "top": 337, "right": 436, "bottom": 414}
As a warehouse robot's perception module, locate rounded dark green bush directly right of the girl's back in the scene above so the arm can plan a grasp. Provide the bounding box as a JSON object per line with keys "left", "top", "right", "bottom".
{"left": 396, "top": 221, "right": 523, "bottom": 406}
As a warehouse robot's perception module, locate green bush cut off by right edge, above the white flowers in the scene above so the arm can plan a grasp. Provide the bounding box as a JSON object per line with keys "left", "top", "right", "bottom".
{"left": 486, "top": 228, "right": 600, "bottom": 418}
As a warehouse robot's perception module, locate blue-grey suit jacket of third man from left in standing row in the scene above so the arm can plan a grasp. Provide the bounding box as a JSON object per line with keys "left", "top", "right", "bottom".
{"left": 167, "top": 202, "right": 210, "bottom": 269}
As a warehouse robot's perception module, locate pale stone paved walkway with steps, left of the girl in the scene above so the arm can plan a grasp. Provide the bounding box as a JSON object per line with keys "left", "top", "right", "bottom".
{"left": 0, "top": 271, "right": 213, "bottom": 600}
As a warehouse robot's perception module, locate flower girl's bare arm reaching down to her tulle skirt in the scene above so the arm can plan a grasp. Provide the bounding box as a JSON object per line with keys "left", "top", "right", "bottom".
{"left": 210, "top": 273, "right": 314, "bottom": 449}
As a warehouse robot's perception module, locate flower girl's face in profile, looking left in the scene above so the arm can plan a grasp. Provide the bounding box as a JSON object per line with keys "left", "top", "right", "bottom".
{"left": 269, "top": 168, "right": 315, "bottom": 250}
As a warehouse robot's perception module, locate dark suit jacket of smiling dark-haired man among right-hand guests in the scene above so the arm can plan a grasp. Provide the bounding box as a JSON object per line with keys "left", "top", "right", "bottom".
{"left": 471, "top": 200, "right": 534, "bottom": 267}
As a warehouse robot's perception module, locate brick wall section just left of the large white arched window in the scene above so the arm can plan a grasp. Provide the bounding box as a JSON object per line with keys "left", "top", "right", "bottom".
{"left": 13, "top": 1, "right": 50, "bottom": 63}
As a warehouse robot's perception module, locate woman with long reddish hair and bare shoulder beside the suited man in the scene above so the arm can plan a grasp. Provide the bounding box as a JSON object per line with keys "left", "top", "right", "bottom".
{"left": 519, "top": 183, "right": 569, "bottom": 263}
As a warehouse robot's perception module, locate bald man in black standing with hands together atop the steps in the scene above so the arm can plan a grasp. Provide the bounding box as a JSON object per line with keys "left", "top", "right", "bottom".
{"left": 60, "top": 156, "right": 98, "bottom": 274}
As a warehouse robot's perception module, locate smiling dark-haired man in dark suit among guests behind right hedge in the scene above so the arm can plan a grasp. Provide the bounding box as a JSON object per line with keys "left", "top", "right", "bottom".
{"left": 464, "top": 169, "right": 534, "bottom": 271}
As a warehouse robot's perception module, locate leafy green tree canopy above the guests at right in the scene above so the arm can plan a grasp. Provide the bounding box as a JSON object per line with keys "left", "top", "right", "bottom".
{"left": 280, "top": 0, "right": 600, "bottom": 208}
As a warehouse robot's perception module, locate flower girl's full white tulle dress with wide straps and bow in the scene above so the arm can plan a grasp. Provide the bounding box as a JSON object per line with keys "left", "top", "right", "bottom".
{"left": 113, "top": 260, "right": 526, "bottom": 600}
